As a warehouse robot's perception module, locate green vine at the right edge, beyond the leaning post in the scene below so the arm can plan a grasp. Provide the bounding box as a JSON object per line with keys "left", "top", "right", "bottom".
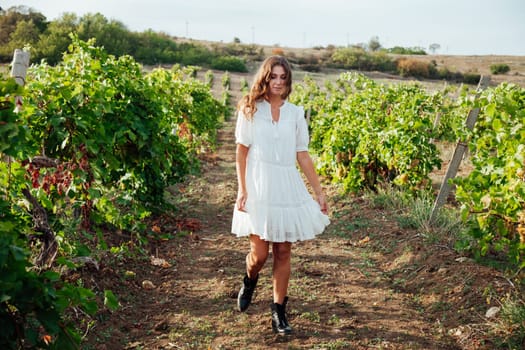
{"left": 453, "top": 83, "right": 525, "bottom": 269}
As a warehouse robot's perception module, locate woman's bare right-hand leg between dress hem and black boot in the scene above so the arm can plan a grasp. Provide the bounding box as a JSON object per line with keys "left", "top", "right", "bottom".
{"left": 272, "top": 242, "right": 292, "bottom": 304}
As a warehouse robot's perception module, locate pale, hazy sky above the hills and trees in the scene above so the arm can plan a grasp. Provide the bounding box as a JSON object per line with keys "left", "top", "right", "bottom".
{"left": 0, "top": 0, "right": 525, "bottom": 56}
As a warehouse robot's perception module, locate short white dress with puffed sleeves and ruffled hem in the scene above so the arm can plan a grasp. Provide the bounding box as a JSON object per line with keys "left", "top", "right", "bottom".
{"left": 232, "top": 101, "right": 330, "bottom": 242}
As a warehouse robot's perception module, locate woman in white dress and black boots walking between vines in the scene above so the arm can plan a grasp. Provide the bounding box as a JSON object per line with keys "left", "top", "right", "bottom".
{"left": 232, "top": 56, "right": 330, "bottom": 334}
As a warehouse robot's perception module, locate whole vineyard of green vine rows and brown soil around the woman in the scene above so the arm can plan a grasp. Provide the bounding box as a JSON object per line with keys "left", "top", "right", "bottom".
{"left": 0, "top": 42, "right": 525, "bottom": 350}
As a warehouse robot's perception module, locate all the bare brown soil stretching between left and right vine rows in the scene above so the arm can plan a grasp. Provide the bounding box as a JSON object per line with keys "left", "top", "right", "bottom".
{"left": 78, "top": 72, "right": 512, "bottom": 350}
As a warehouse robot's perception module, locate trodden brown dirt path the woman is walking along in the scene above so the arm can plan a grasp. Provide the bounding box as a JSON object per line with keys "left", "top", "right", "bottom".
{"left": 117, "top": 115, "right": 455, "bottom": 349}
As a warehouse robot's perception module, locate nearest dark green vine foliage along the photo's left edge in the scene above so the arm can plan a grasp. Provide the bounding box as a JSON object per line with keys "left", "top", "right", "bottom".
{"left": 0, "top": 68, "right": 97, "bottom": 350}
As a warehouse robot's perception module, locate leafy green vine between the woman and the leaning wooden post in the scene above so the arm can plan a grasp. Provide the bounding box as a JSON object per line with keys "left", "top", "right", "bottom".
{"left": 291, "top": 73, "right": 442, "bottom": 193}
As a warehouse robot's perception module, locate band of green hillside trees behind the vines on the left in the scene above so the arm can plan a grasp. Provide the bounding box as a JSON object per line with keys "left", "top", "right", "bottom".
{"left": 0, "top": 6, "right": 246, "bottom": 71}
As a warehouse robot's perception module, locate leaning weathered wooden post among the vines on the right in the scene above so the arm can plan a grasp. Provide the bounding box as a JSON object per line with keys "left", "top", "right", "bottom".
{"left": 430, "top": 76, "right": 490, "bottom": 224}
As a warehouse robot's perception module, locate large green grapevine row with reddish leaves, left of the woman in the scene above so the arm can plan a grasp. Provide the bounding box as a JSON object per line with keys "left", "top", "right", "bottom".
{"left": 0, "top": 36, "right": 226, "bottom": 349}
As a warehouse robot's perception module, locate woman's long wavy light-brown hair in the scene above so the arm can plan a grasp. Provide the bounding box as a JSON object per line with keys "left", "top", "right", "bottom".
{"left": 237, "top": 56, "right": 292, "bottom": 120}
